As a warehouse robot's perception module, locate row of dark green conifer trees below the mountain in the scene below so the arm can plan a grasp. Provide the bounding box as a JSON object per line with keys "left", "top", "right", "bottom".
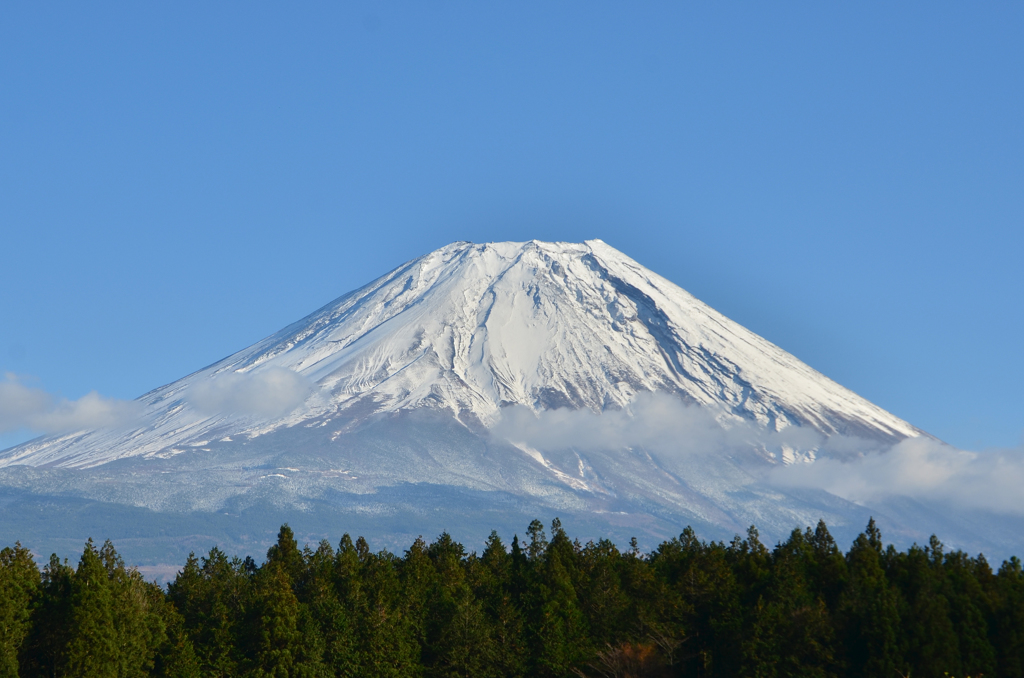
{"left": 0, "top": 519, "right": 1024, "bottom": 678}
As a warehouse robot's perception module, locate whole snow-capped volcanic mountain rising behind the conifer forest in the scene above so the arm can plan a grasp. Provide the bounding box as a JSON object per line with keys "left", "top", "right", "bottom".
{"left": 0, "top": 241, "right": 1007, "bottom": 559}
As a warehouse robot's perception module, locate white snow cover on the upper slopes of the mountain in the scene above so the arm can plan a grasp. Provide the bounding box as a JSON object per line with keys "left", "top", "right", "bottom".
{"left": 0, "top": 241, "right": 921, "bottom": 468}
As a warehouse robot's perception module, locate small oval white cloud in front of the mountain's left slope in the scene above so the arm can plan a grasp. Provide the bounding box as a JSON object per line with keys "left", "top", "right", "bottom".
{"left": 185, "top": 368, "right": 313, "bottom": 419}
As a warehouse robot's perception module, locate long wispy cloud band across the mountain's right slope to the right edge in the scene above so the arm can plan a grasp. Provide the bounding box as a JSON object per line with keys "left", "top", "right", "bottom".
{"left": 492, "top": 393, "right": 1024, "bottom": 514}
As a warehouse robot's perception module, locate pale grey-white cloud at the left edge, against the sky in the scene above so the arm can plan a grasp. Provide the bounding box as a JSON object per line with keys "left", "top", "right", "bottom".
{"left": 0, "top": 374, "right": 139, "bottom": 433}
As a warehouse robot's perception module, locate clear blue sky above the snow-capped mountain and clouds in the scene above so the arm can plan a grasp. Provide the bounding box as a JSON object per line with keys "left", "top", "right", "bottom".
{"left": 0, "top": 1, "right": 1024, "bottom": 449}
